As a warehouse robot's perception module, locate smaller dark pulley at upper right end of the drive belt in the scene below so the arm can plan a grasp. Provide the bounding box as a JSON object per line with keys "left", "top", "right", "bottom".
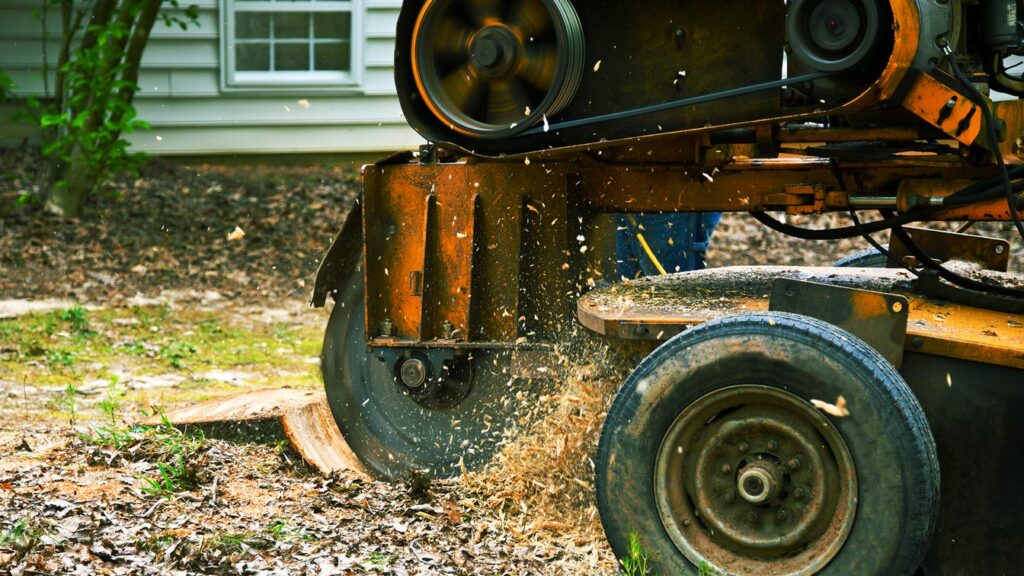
{"left": 785, "top": 0, "right": 886, "bottom": 72}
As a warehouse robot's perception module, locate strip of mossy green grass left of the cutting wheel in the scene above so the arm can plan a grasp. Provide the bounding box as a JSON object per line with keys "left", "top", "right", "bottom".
{"left": 0, "top": 306, "right": 323, "bottom": 421}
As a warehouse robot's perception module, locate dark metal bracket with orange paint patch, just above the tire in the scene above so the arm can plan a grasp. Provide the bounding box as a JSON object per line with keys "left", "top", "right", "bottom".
{"left": 768, "top": 278, "right": 910, "bottom": 368}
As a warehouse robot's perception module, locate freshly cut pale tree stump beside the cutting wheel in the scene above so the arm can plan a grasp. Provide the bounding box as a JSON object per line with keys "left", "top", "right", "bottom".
{"left": 143, "top": 388, "right": 369, "bottom": 478}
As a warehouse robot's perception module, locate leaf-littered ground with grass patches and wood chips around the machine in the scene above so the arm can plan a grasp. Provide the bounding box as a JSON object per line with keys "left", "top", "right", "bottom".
{"left": 0, "top": 145, "right": 1024, "bottom": 575}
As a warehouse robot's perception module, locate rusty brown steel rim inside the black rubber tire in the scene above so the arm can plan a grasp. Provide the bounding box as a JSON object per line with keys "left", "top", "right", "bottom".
{"left": 654, "top": 385, "right": 857, "bottom": 576}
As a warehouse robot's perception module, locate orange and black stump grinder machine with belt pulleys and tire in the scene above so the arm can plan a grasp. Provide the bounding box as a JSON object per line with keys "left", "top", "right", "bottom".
{"left": 312, "top": 0, "right": 1024, "bottom": 576}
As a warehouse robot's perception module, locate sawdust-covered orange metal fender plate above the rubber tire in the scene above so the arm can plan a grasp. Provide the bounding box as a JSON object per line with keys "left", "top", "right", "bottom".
{"left": 577, "top": 266, "right": 1024, "bottom": 369}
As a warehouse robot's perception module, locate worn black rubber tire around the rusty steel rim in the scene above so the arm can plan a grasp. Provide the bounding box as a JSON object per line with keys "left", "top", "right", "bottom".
{"left": 596, "top": 313, "right": 939, "bottom": 576}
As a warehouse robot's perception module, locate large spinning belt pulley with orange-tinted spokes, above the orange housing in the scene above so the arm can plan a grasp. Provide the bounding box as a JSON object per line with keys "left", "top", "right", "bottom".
{"left": 413, "top": 0, "right": 585, "bottom": 138}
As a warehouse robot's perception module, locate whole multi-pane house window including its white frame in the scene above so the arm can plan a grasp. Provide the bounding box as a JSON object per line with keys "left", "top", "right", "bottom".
{"left": 222, "top": 0, "right": 359, "bottom": 88}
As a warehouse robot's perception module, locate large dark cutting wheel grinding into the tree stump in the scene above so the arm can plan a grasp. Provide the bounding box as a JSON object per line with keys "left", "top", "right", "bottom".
{"left": 321, "top": 259, "right": 542, "bottom": 479}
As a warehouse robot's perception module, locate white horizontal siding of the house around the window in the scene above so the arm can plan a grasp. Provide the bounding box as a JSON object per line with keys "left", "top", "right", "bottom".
{"left": 0, "top": 0, "right": 422, "bottom": 155}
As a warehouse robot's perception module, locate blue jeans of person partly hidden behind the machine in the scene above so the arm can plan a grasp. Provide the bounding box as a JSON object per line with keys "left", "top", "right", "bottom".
{"left": 615, "top": 212, "right": 722, "bottom": 278}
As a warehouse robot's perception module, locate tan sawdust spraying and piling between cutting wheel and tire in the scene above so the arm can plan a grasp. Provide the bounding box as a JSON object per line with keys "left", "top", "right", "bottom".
{"left": 463, "top": 334, "right": 644, "bottom": 537}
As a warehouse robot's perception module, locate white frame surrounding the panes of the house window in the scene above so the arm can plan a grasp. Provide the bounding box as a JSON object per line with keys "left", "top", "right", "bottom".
{"left": 220, "top": 0, "right": 366, "bottom": 92}
